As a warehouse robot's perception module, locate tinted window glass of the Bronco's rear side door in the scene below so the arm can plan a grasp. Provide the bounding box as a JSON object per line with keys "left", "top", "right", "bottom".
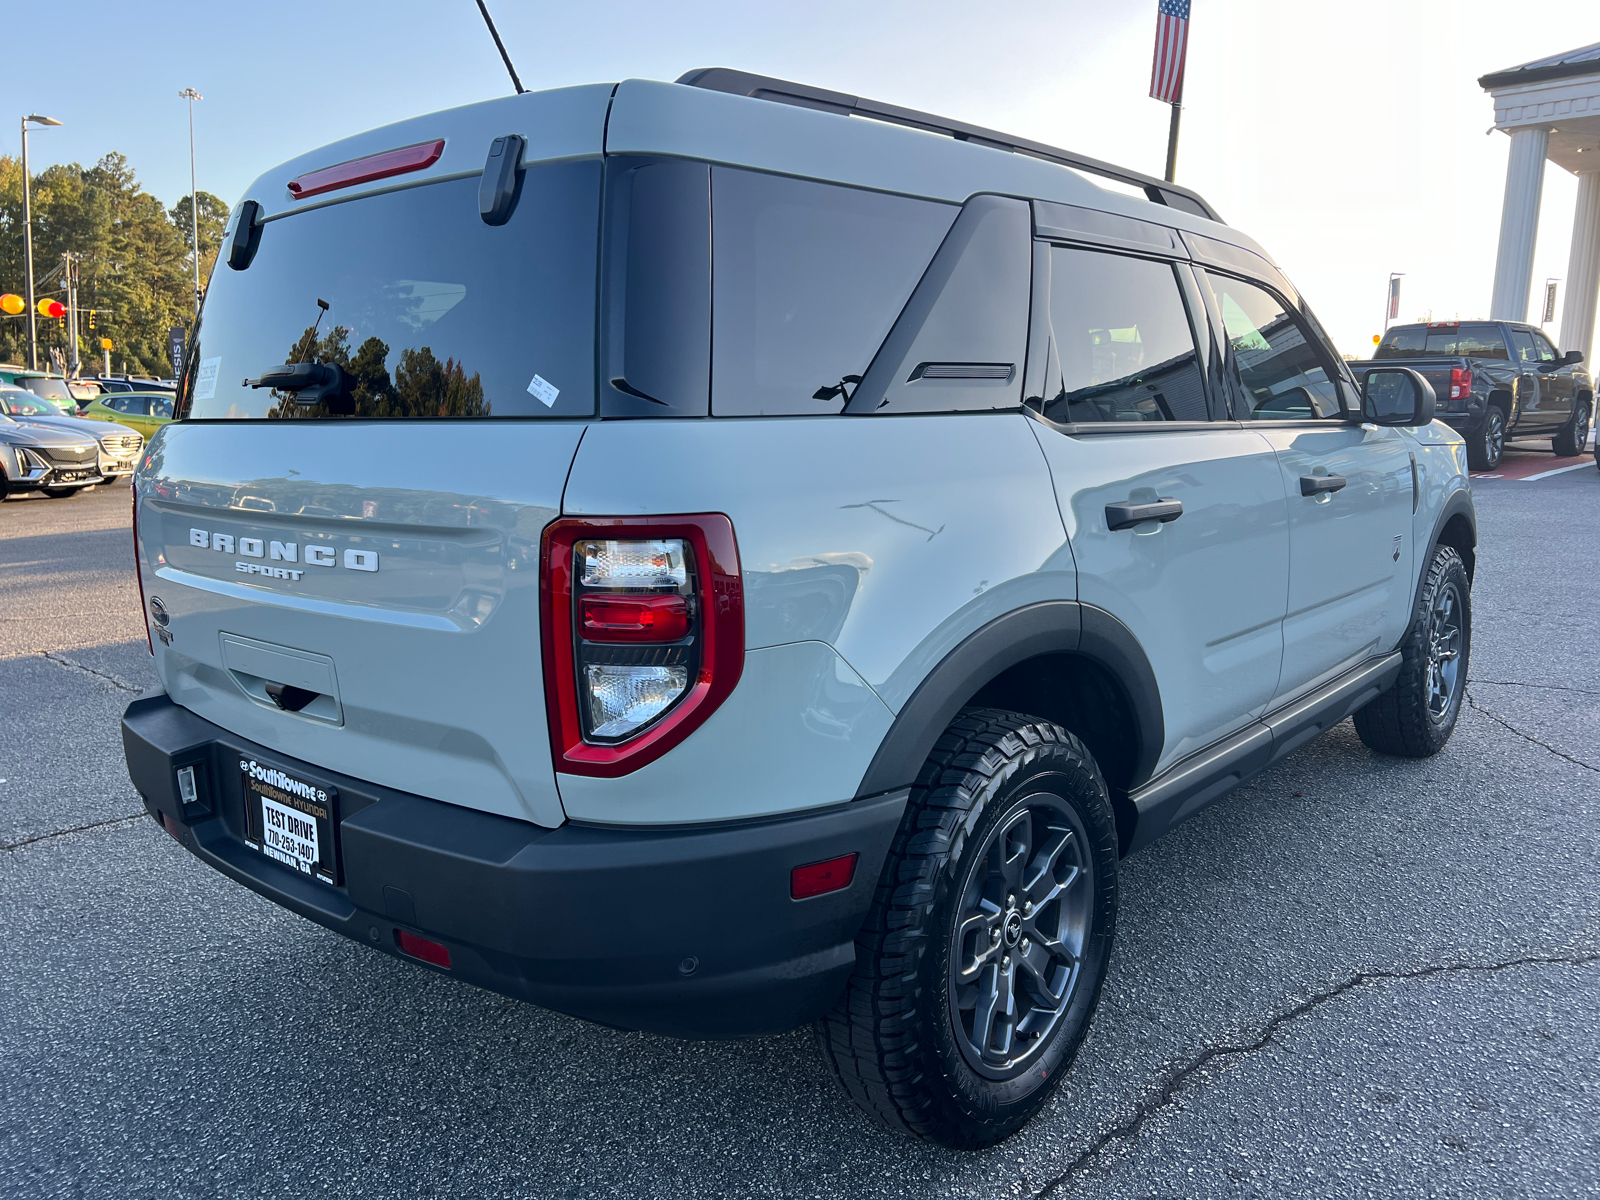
{"left": 1030, "top": 246, "right": 1210, "bottom": 422}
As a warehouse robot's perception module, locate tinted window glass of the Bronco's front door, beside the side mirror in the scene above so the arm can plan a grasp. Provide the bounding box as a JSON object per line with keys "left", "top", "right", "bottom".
{"left": 1208, "top": 274, "right": 1341, "bottom": 421}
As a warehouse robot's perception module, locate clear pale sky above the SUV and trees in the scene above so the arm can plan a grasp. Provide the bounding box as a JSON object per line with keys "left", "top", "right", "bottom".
{"left": 9, "top": 0, "right": 1600, "bottom": 354}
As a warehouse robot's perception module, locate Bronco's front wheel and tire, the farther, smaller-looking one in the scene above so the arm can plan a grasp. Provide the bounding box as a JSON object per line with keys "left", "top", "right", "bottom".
{"left": 1355, "top": 546, "right": 1472, "bottom": 758}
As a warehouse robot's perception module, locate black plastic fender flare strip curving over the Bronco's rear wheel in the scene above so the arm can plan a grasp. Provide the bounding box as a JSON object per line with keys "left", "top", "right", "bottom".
{"left": 856, "top": 600, "right": 1166, "bottom": 797}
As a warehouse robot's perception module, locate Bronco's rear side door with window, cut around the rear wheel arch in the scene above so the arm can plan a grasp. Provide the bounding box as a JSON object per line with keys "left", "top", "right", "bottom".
{"left": 1029, "top": 245, "right": 1288, "bottom": 770}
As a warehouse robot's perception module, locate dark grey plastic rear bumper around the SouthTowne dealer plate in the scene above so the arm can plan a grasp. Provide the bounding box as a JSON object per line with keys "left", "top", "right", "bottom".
{"left": 122, "top": 696, "right": 906, "bottom": 1038}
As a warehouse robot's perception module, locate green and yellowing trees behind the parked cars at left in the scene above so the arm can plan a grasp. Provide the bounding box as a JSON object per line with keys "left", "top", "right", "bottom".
{"left": 0, "top": 154, "right": 227, "bottom": 378}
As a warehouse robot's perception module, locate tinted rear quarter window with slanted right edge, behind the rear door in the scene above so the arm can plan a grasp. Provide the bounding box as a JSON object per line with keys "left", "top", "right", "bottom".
{"left": 710, "top": 168, "right": 958, "bottom": 416}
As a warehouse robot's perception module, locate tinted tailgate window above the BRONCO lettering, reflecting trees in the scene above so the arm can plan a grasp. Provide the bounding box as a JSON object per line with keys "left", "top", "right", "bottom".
{"left": 186, "top": 162, "right": 600, "bottom": 419}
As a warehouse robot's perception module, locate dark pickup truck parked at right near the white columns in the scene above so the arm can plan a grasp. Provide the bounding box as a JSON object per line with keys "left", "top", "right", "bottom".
{"left": 1350, "top": 322, "right": 1595, "bottom": 470}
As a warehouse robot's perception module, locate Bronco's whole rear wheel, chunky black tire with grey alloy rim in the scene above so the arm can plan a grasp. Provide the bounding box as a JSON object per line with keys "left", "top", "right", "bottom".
{"left": 816, "top": 709, "right": 1117, "bottom": 1150}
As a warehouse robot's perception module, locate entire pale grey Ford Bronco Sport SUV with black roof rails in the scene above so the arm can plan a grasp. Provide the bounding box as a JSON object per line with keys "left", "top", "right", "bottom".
{"left": 123, "top": 69, "right": 1475, "bottom": 1147}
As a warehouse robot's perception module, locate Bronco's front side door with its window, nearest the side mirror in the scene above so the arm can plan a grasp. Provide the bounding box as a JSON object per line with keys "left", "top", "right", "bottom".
{"left": 1205, "top": 272, "right": 1414, "bottom": 706}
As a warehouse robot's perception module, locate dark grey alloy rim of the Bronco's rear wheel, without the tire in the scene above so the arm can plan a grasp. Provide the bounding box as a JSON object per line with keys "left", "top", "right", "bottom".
{"left": 949, "top": 792, "right": 1094, "bottom": 1080}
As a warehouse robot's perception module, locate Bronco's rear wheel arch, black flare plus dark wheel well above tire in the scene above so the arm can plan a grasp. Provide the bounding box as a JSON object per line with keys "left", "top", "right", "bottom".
{"left": 858, "top": 600, "right": 1166, "bottom": 842}
